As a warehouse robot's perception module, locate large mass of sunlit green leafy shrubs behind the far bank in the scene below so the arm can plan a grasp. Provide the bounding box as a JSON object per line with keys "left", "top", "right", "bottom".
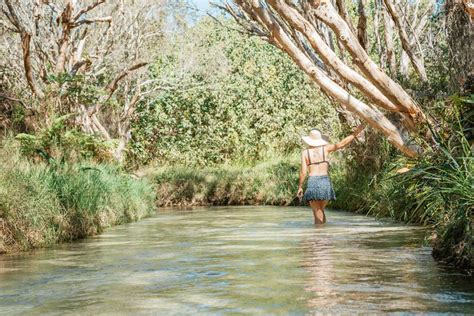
{"left": 130, "top": 20, "right": 340, "bottom": 165}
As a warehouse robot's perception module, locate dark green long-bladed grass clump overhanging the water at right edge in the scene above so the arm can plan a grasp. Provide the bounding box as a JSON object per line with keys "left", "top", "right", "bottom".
{"left": 400, "top": 105, "right": 474, "bottom": 268}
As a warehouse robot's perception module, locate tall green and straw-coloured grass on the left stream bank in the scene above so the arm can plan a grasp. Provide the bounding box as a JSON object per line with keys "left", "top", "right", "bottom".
{"left": 0, "top": 152, "right": 155, "bottom": 253}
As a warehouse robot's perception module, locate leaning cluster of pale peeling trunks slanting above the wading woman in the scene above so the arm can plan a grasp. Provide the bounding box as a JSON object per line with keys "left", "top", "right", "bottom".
{"left": 223, "top": 0, "right": 425, "bottom": 156}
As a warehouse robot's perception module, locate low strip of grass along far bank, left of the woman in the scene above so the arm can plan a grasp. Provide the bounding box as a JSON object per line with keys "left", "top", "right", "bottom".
{"left": 150, "top": 157, "right": 299, "bottom": 206}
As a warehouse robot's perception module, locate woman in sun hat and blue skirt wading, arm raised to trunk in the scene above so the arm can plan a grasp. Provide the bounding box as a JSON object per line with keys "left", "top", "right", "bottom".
{"left": 297, "top": 124, "right": 365, "bottom": 224}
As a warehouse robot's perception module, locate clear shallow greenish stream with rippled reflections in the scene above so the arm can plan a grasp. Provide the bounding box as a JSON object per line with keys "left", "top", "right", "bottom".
{"left": 0, "top": 207, "right": 474, "bottom": 315}
